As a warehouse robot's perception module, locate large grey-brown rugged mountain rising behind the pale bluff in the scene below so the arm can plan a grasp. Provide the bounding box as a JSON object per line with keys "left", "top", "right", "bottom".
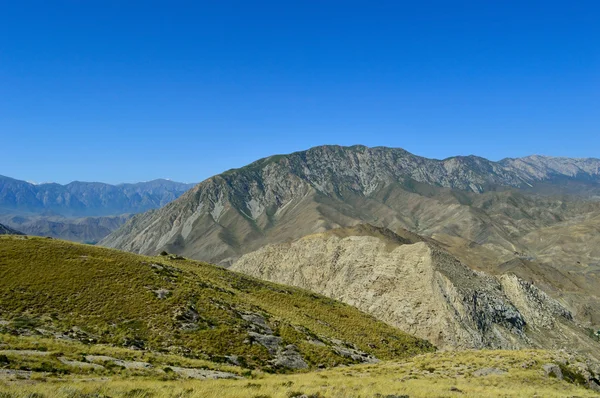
{"left": 101, "top": 146, "right": 600, "bottom": 265}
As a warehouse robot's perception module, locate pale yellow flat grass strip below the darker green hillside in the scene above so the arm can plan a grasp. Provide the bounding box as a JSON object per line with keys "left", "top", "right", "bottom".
{"left": 0, "top": 350, "right": 599, "bottom": 398}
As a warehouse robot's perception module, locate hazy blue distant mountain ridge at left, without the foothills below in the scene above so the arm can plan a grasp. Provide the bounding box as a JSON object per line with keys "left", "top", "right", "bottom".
{"left": 0, "top": 176, "right": 194, "bottom": 217}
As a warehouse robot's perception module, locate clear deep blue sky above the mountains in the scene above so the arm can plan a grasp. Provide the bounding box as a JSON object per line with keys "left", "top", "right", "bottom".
{"left": 0, "top": 0, "right": 600, "bottom": 183}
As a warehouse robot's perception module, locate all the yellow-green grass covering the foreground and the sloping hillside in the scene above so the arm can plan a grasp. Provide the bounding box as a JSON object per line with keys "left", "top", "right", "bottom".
{"left": 0, "top": 237, "right": 598, "bottom": 398}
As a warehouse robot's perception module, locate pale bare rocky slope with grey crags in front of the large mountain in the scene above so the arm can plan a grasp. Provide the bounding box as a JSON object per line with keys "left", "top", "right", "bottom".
{"left": 231, "top": 225, "right": 600, "bottom": 358}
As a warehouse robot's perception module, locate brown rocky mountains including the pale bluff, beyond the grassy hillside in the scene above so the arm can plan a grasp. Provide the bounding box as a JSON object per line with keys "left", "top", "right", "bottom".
{"left": 100, "top": 146, "right": 600, "bottom": 358}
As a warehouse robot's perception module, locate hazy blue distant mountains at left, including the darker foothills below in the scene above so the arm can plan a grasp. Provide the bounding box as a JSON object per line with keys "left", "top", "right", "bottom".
{"left": 0, "top": 176, "right": 194, "bottom": 243}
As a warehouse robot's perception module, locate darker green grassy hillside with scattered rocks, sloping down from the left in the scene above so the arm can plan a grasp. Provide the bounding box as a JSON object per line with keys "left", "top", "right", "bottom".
{"left": 0, "top": 236, "right": 433, "bottom": 372}
